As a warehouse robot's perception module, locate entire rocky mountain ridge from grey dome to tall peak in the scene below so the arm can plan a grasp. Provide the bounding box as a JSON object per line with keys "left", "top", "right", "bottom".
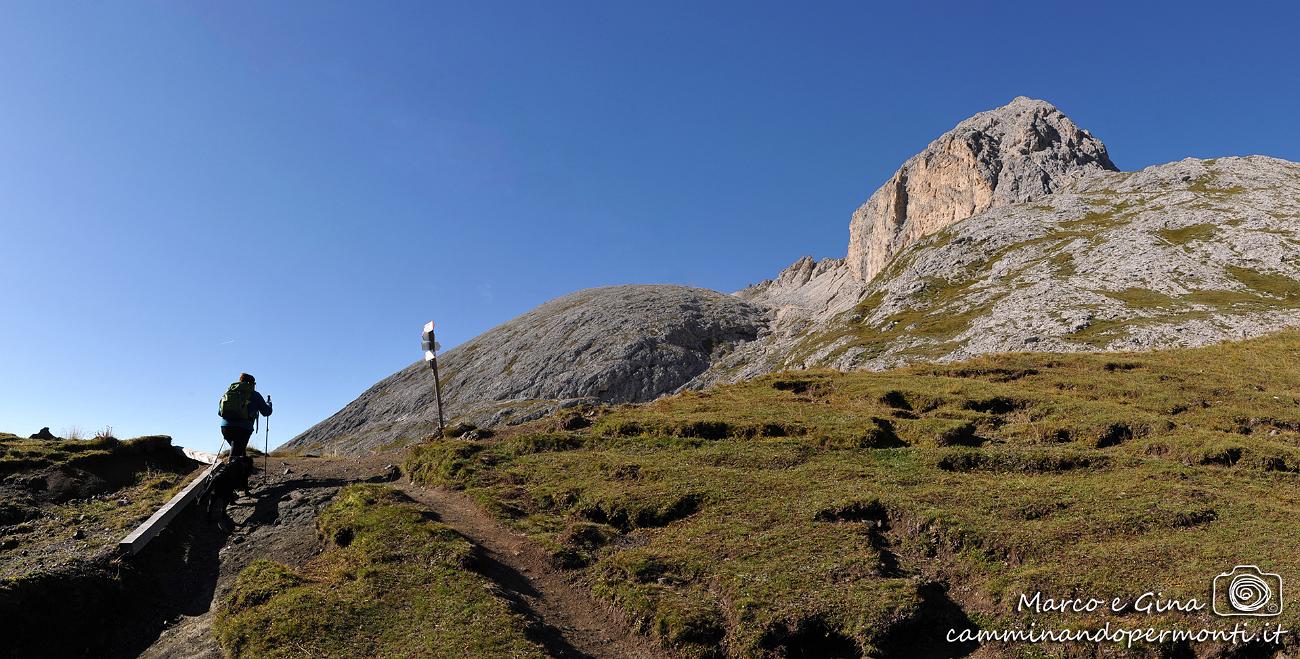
{"left": 287, "top": 96, "right": 1300, "bottom": 452}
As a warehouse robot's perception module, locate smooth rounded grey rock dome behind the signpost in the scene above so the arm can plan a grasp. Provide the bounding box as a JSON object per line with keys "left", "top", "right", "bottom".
{"left": 286, "top": 286, "right": 768, "bottom": 454}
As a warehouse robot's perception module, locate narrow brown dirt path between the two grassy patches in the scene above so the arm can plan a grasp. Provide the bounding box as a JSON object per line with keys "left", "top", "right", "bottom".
{"left": 398, "top": 481, "right": 667, "bottom": 659}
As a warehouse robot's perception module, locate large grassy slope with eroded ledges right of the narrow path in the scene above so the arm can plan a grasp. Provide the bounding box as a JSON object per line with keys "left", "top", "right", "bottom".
{"left": 407, "top": 333, "right": 1300, "bottom": 656}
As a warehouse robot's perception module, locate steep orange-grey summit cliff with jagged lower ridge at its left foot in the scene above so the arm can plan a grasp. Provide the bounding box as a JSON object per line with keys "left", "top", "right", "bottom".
{"left": 692, "top": 96, "right": 1115, "bottom": 387}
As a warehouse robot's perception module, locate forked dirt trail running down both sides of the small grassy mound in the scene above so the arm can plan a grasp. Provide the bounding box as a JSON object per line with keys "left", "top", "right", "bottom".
{"left": 133, "top": 455, "right": 666, "bottom": 659}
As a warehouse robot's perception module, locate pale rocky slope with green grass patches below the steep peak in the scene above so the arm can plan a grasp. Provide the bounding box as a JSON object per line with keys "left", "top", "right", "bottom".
{"left": 728, "top": 156, "right": 1300, "bottom": 371}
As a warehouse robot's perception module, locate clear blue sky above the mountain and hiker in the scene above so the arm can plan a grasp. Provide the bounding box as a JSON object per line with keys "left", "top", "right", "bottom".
{"left": 0, "top": 1, "right": 1300, "bottom": 450}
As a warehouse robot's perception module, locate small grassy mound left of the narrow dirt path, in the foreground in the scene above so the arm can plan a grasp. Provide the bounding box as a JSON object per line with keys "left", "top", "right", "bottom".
{"left": 215, "top": 485, "right": 545, "bottom": 658}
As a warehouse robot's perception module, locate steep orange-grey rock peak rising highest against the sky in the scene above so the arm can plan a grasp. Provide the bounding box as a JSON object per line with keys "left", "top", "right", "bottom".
{"left": 846, "top": 96, "right": 1115, "bottom": 282}
